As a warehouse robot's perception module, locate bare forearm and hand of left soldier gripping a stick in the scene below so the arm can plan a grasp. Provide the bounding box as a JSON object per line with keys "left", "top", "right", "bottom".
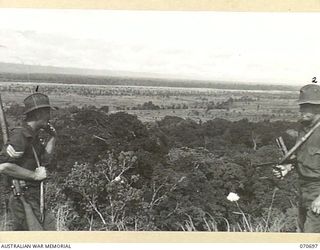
{"left": 0, "top": 162, "right": 47, "bottom": 181}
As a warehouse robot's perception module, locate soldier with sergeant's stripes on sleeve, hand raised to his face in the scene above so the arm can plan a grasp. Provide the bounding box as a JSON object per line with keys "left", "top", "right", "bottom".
{"left": 0, "top": 93, "right": 57, "bottom": 230}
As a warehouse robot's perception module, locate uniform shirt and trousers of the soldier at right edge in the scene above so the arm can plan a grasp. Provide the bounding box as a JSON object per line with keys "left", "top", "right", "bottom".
{"left": 296, "top": 128, "right": 320, "bottom": 233}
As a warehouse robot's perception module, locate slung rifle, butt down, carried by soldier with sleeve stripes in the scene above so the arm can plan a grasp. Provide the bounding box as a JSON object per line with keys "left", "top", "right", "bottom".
{"left": 0, "top": 95, "right": 43, "bottom": 231}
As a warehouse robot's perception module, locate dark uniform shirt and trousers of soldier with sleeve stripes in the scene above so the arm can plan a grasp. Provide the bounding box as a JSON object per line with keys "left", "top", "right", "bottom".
{"left": 0, "top": 124, "right": 54, "bottom": 230}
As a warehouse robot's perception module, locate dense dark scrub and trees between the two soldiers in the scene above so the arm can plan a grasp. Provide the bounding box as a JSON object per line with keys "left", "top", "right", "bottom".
{"left": 3, "top": 107, "right": 297, "bottom": 231}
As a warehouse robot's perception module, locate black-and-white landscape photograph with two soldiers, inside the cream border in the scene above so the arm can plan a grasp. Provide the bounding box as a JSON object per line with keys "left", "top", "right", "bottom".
{"left": 0, "top": 8, "right": 320, "bottom": 233}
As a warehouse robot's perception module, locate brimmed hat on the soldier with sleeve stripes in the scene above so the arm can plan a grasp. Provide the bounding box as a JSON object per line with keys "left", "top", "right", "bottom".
{"left": 23, "top": 92, "right": 55, "bottom": 114}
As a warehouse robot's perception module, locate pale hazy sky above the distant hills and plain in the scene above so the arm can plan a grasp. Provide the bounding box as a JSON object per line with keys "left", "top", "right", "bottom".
{"left": 0, "top": 9, "right": 320, "bottom": 85}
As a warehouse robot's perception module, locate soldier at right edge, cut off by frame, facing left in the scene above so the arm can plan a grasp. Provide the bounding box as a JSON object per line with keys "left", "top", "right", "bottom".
{"left": 274, "top": 84, "right": 320, "bottom": 233}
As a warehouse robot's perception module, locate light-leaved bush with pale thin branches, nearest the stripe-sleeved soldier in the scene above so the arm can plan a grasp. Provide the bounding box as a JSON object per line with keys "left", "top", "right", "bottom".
{"left": 59, "top": 152, "right": 159, "bottom": 230}
